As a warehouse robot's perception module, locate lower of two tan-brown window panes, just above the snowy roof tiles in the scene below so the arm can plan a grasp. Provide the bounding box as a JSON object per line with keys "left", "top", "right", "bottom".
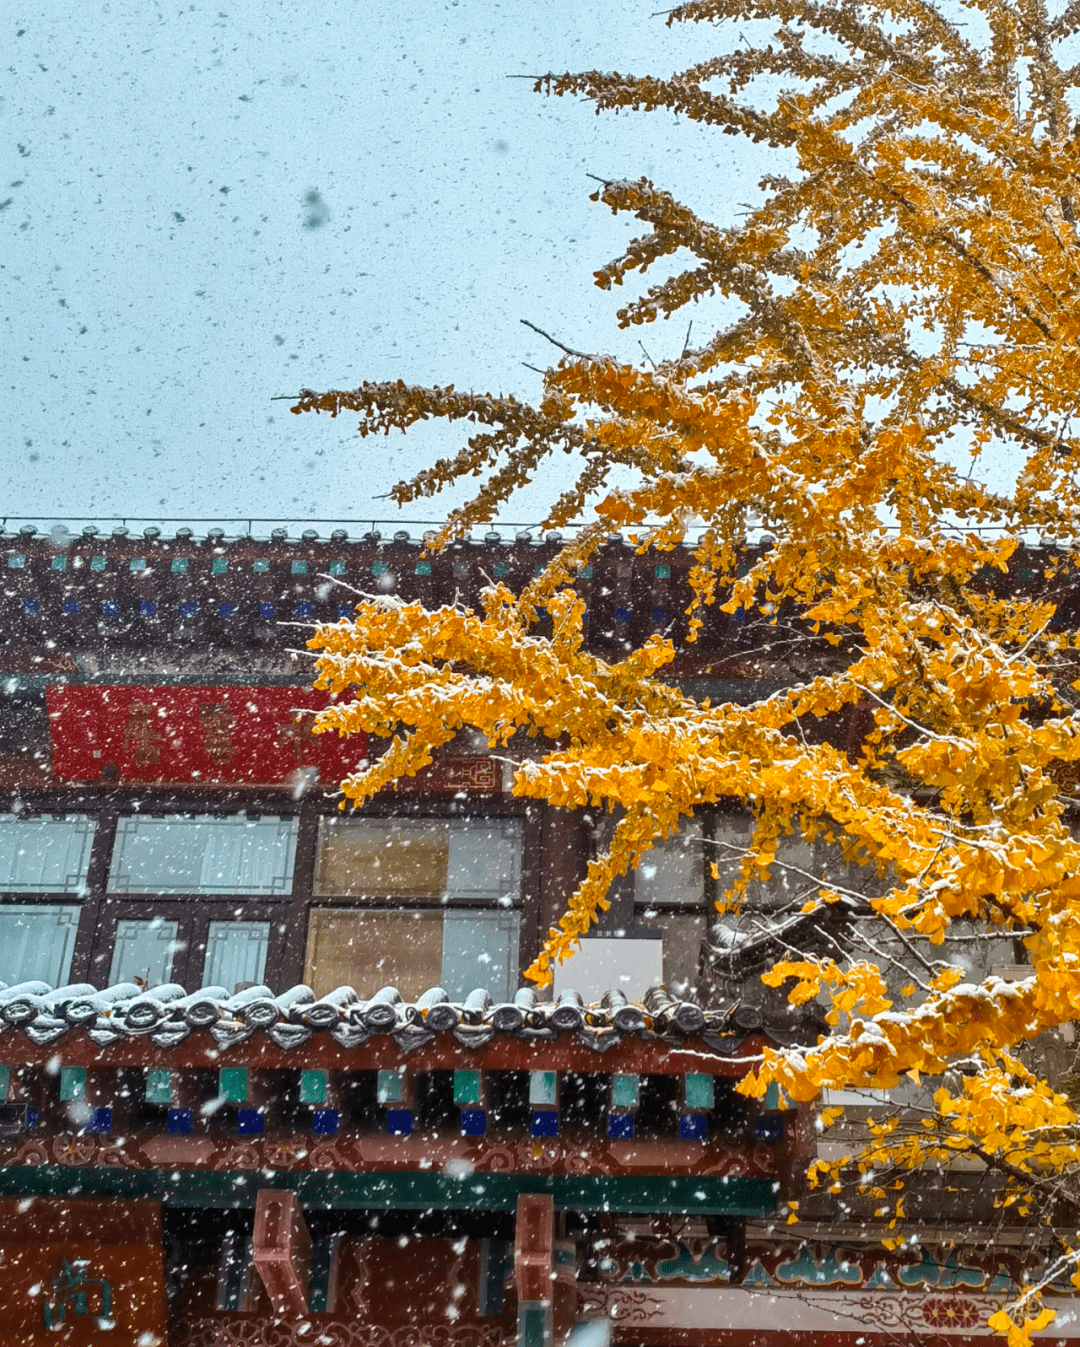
{"left": 304, "top": 908, "right": 443, "bottom": 1001}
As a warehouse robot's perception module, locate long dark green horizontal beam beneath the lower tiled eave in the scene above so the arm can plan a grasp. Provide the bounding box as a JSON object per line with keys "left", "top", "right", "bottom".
{"left": 0, "top": 1165, "right": 776, "bottom": 1216}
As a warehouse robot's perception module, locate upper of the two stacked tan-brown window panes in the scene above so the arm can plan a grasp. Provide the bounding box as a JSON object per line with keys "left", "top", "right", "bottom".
{"left": 315, "top": 819, "right": 450, "bottom": 898}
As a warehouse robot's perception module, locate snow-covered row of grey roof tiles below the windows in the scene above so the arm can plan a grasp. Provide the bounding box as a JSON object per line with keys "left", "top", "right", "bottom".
{"left": 0, "top": 982, "right": 817, "bottom": 1056}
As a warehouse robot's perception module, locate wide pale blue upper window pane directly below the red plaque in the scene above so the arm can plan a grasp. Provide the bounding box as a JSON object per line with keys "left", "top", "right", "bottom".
{"left": 109, "top": 814, "right": 296, "bottom": 896}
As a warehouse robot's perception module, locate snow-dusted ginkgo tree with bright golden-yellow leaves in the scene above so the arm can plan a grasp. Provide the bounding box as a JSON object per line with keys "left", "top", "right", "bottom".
{"left": 292, "top": 0, "right": 1080, "bottom": 1343}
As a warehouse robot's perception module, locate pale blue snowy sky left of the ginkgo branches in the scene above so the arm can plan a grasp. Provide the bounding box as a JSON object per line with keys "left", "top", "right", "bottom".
{"left": 0, "top": 0, "right": 765, "bottom": 527}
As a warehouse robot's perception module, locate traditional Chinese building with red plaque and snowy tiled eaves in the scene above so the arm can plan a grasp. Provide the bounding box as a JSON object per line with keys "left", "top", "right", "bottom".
{"left": 0, "top": 528, "right": 1080, "bottom": 1347}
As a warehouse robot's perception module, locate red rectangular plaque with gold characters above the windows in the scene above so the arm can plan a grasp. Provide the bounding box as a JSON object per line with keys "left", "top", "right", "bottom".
{"left": 48, "top": 683, "right": 366, "bottom": 785}
